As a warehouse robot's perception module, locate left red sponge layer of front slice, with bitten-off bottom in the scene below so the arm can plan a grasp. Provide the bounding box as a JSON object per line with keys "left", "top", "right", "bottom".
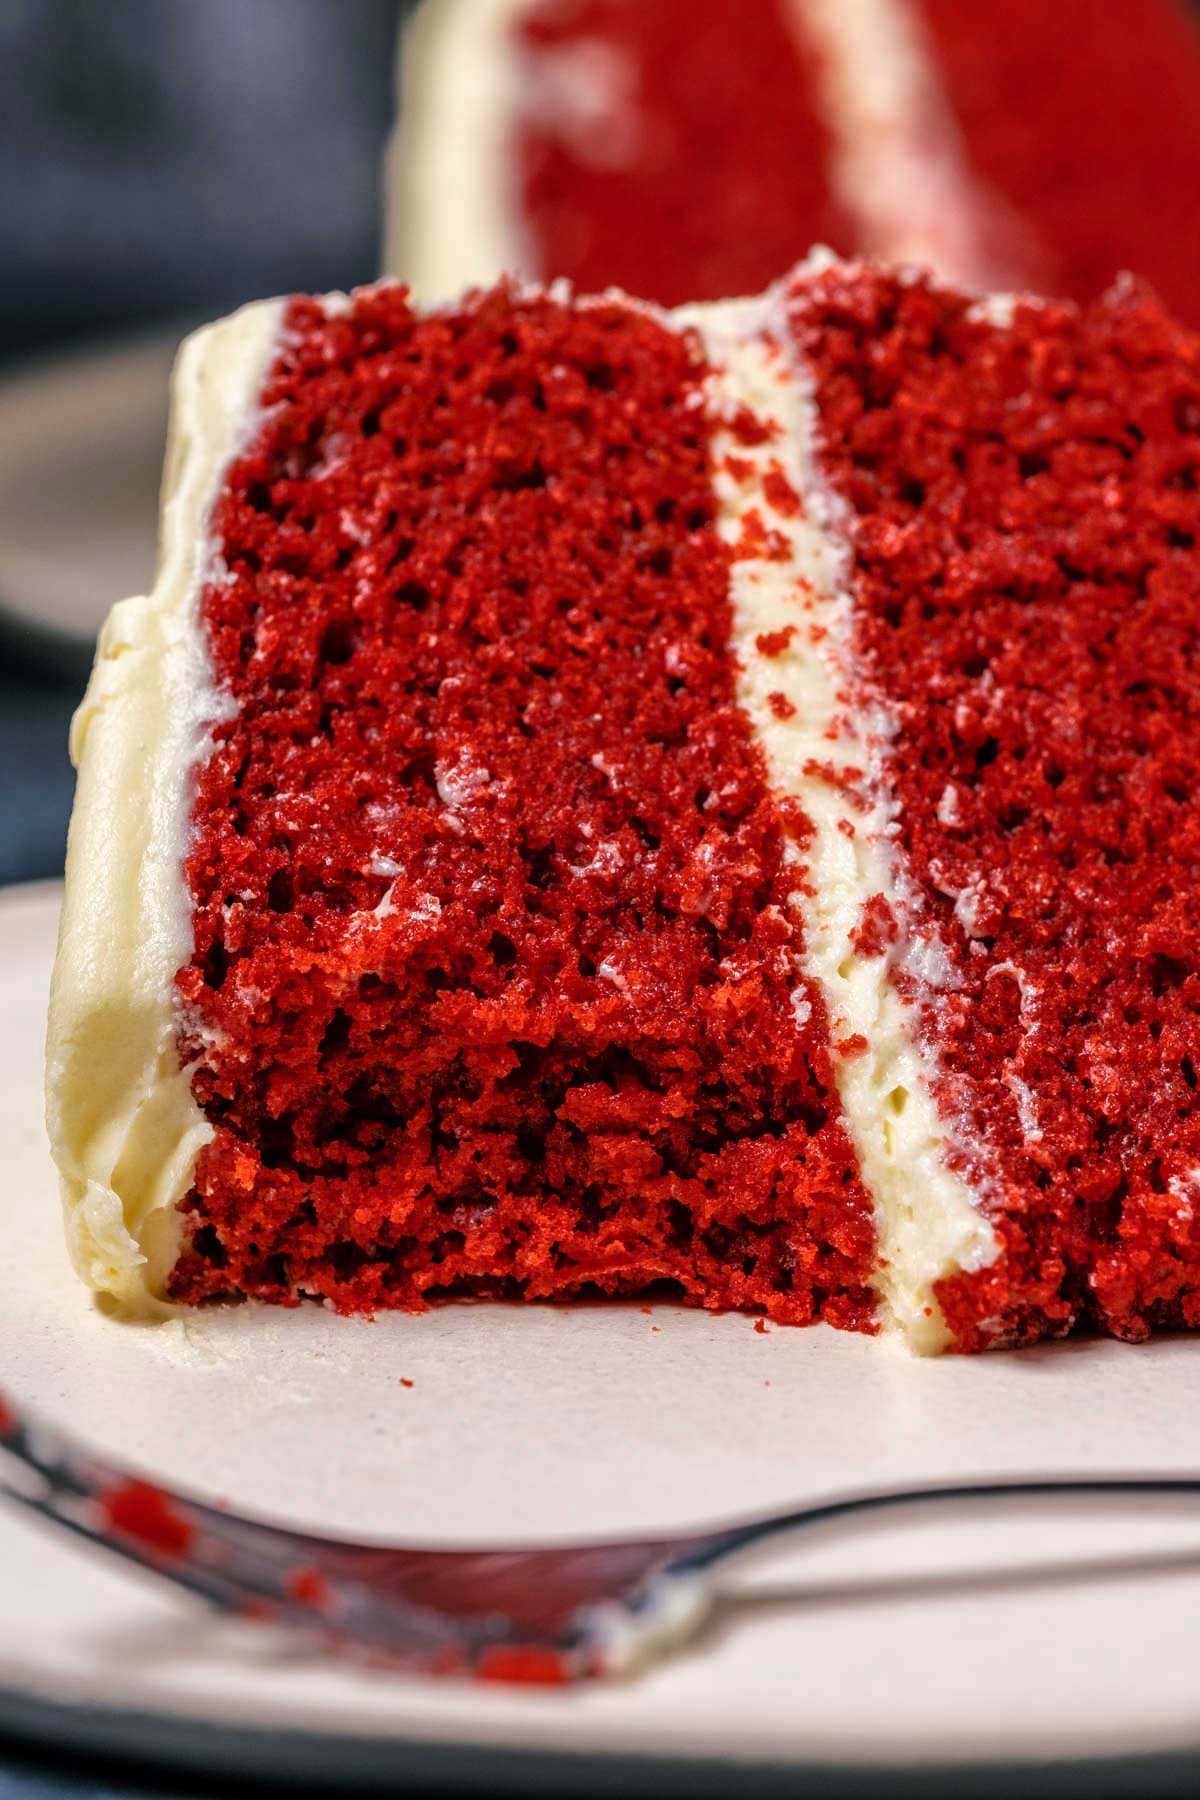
{"left": 171, "top": 288, "right": 874, "bottom": 1328}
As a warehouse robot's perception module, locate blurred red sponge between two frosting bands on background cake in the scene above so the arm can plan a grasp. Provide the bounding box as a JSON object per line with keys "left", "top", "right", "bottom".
{"left": 515, "top": 0, "right": 853, "bottom": 306}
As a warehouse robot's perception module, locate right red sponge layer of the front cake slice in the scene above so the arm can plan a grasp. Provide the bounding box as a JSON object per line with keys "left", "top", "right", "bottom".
{"left": 792, "top": 270, "right": 1200, "bottom": 1348}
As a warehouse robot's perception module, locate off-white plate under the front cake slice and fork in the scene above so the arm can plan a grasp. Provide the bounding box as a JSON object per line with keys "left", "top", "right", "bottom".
{"left": 0, "top": 887, "right": 1200, "bottom": 1793}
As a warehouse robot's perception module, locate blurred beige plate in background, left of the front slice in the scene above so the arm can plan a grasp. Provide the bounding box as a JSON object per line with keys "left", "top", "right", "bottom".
{"left": 0, "top": 329, "right": 180, "bottom": 639}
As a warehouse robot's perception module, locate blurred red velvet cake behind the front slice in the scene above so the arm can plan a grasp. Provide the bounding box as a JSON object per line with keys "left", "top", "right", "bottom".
{"left": 387, "top": 0, "right": 1200, "bottom": 324}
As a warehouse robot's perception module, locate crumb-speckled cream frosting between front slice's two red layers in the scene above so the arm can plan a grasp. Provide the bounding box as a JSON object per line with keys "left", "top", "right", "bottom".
{"left": 690, "top": 284, "right": 999, "bottom": 1352}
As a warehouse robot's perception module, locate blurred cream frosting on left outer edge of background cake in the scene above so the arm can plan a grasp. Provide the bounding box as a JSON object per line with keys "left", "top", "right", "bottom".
{"left": 383, "top": 0, "right": 534, "bottom": 306}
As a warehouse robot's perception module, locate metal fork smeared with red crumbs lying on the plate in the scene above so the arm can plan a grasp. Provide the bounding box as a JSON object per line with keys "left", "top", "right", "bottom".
{"left": 0, "top": 1395, "right": 1200, "bottom": 1687}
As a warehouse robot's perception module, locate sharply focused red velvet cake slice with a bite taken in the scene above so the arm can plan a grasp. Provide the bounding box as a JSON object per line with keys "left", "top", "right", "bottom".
{"left": 49, "top": 257, "right": 1200, "bottom": 1350}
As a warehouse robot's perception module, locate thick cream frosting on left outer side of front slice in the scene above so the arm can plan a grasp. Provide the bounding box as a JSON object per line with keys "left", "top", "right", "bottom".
{"left": 47, "top": 301, "right": 282, "bottom": 1314}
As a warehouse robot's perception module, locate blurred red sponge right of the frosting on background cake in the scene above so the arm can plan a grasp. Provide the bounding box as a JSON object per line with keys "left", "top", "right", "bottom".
{"left": 919, "top": 0, "right": 1200, "bottom": 324}
